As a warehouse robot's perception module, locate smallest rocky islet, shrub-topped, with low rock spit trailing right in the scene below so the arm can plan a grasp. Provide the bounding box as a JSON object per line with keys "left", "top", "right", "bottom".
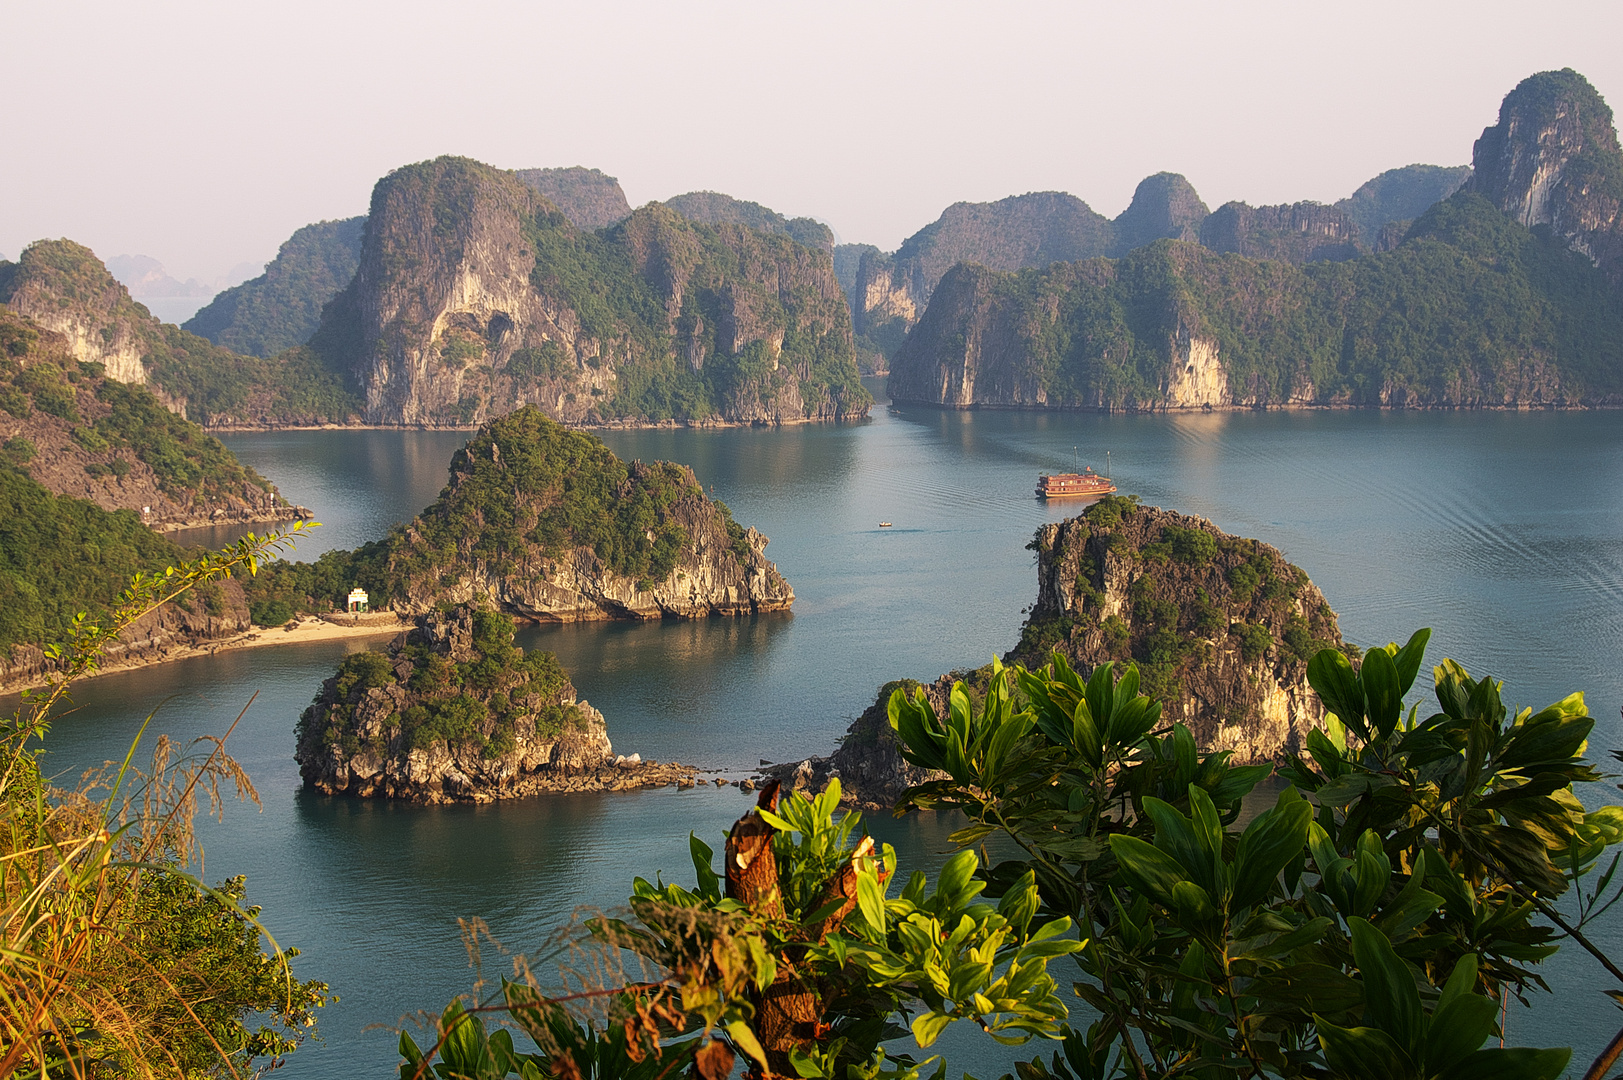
{"left": 294, "top": 607, "right": 690, "bottom": 802}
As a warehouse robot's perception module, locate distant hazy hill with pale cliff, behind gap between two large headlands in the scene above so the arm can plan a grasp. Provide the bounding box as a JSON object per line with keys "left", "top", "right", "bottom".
{"left": 852, "top": 192, "right": 1113, "bottom": 351}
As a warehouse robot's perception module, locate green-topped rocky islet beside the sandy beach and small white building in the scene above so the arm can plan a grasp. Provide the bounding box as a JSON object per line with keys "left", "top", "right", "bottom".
{"left": 370, "top": 408, "right": 795, "bottom": 622}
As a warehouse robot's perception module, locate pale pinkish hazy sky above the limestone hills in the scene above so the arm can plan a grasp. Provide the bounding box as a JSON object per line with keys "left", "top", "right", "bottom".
{"left": 0, "top": 0, "right": 1623, "bottom": 279}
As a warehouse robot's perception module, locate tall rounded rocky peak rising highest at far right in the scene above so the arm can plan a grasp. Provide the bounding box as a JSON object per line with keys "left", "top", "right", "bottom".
{"left": 1466, "top": 68, "right": 1623, "bottom": 283}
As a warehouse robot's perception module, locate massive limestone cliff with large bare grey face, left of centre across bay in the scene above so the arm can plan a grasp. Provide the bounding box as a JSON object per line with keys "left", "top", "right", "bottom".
{"left": 312, "top": 158, "right": 870, "bottom": 424}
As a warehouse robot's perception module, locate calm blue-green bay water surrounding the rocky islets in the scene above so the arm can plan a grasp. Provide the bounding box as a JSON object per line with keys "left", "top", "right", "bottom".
{"left": 28, "top": 384, "right": 1623, "bottom": 1077}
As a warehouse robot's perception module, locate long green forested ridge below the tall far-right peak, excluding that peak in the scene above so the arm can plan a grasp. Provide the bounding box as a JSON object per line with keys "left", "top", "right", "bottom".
{"left": 889, "top": 193, "right": 1623, "bottom": 409}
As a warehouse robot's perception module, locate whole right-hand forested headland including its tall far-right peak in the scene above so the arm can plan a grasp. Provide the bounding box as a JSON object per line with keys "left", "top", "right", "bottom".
{"left": 889, "top": 71, "right": 1623, "bottom": 409}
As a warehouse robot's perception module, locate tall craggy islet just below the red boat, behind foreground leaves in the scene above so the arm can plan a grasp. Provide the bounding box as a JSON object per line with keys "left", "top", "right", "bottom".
{"left": 1008, "top": 499, "right": 1341, "bottom": 763}
